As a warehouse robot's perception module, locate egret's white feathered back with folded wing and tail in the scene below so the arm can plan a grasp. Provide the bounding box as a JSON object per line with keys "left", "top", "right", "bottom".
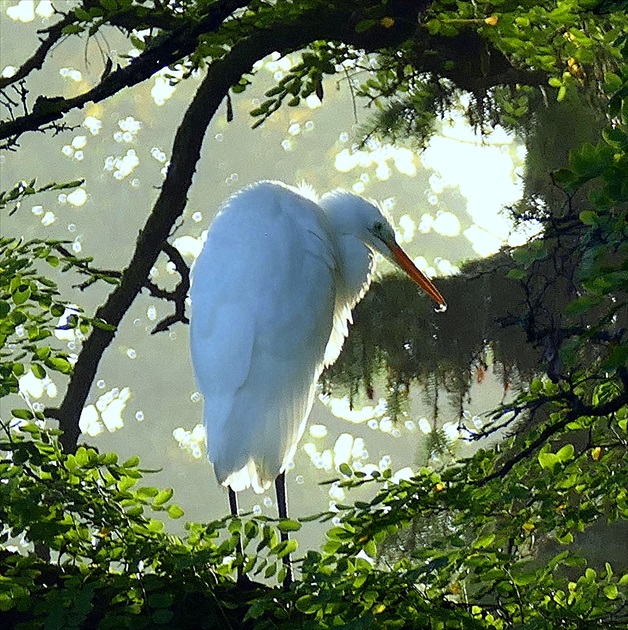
{"left": 191, "top": 182, "right": 335, "bottom": 490}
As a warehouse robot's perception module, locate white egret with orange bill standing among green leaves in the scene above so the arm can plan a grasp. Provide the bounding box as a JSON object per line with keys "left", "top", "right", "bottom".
{"left": 190, "top": 181, "right": 446, "bottom": 584}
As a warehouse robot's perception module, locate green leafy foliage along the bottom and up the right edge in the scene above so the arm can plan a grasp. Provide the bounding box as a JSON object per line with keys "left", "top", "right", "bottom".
{"left": 0, "top": 95, "right": 628, "bottom": 630}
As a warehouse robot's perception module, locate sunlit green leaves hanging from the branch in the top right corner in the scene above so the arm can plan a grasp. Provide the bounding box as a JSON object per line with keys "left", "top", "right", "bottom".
{"left": 356, "top": 0, "right": 628, "bottom": 146}
